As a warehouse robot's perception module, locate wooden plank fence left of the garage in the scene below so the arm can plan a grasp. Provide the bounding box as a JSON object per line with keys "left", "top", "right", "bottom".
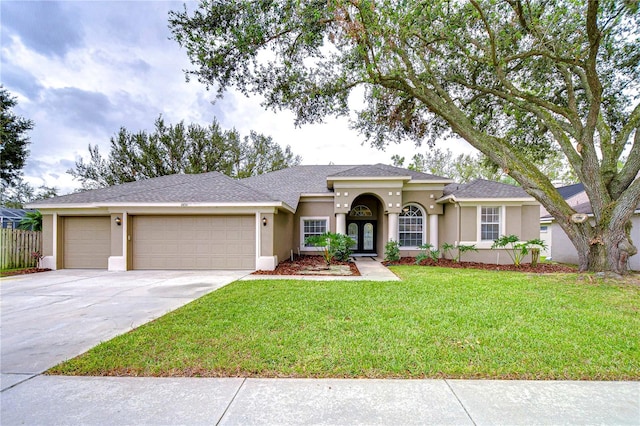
{"left": 0, "top": 228, "right": 42, "bottom": 269}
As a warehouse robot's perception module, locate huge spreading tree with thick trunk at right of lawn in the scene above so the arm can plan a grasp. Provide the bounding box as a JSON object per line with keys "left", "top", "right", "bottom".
{"left": 170, "top": 0, "right": 640, "bottom": 273}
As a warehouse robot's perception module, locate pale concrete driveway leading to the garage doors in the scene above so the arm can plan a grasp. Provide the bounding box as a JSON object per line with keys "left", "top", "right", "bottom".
{"left": 0, "top": 270, "right": 249, "bottom": 390}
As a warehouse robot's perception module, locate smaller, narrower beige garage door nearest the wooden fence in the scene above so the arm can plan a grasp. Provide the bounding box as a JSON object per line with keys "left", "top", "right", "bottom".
{"left": 63, "top": 217, "right": 111, "bottom": 269}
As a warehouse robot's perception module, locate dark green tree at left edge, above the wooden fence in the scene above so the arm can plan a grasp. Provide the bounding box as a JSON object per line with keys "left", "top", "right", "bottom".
{"left": 0, "top": 86, "right": 33, "bottom": 186}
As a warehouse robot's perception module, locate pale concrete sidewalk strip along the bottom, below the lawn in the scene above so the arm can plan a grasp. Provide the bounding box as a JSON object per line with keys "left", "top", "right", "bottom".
{"left": 1, "top": 376, "right": 640, "bottom": 425}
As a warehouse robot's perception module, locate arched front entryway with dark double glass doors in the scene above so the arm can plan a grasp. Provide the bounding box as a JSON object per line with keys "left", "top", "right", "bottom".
{"left": 346, "top": 194, "right": 384, "bottom": 255}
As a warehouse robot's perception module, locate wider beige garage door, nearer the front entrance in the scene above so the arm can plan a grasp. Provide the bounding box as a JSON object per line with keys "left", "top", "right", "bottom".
{"left": 132, "top": 216, "right": 256, "bottom": 269}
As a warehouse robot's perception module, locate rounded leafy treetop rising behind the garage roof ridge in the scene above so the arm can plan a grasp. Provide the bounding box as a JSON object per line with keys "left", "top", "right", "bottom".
{"left": 68, "top": 117, "right": 301, "bottom": 189}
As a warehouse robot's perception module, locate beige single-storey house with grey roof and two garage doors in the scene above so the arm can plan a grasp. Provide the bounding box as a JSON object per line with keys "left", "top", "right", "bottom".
{"left": 31, "top": 164, "right": 539, "bottom": 271}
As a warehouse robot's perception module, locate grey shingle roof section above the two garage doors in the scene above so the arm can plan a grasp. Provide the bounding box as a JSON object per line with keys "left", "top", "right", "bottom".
{"left": 31, "top": 172, "right": 278, "bottom": 207}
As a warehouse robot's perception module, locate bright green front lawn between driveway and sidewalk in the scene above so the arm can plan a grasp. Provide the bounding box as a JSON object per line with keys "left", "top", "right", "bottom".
{"left": 49, "top": 266, "right": 640, "bottom": 380}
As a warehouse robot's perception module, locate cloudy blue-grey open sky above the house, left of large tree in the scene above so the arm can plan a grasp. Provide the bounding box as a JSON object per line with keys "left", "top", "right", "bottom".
{"left": 0, "top": 0, "right": 473, "bottom": 195}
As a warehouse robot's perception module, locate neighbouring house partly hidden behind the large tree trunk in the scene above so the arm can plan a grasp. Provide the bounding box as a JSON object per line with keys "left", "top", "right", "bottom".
{"left": 540, "top": 190, "right": 640, "bottom": 271}
